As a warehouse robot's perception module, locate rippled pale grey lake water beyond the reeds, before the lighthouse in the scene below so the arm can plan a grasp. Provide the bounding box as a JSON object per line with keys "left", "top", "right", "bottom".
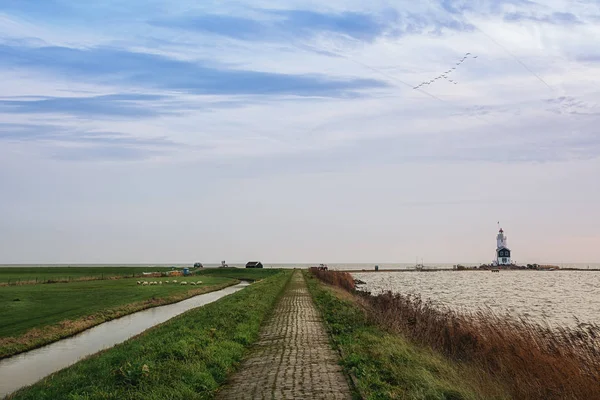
{"left": 352, "top": 271, "right": 600, "bottom": 326}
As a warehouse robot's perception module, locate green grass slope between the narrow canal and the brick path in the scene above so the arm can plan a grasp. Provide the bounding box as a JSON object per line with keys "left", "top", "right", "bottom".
{"left": 9, "top": 271, "right": 291, "bottom": 400}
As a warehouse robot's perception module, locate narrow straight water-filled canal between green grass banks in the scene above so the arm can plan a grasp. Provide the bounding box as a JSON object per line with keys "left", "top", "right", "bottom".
{"left": 0, "top": 282, "right": 249, "bottom": 398}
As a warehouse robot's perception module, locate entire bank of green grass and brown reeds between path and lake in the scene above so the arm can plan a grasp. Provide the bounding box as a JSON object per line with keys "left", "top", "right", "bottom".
{"left": 306, "top": 268, "right": 600, "bottom": 400}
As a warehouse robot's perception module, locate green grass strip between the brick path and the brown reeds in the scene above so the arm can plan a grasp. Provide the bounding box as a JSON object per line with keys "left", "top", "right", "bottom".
{"left": 306, "top": 274, "right": 510, "bottom": 400}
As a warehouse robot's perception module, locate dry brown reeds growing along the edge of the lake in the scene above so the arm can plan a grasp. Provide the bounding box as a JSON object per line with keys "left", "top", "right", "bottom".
{"left": 308, "top": 272, "right": 600, "bottom": 400}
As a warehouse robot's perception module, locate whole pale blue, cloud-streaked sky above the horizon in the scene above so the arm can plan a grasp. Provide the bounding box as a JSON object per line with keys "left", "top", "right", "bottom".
{"left": 0, "top": 0, "right": 600, "bottom": 264}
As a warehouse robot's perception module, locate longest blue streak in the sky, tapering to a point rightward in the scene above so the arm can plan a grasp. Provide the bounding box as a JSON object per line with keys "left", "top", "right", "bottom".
{"left": 0, "top": 45, "right": 387, "bottom": 97}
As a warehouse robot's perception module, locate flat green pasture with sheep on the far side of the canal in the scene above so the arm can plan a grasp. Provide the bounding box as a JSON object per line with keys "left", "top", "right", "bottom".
{"left": 0, "top": 276, "right": 238, "bottom": 358}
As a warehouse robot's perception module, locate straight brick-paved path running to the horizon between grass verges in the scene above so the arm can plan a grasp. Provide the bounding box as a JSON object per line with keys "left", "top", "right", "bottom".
{"left": 217, "top": 271, "right": 352, "bottom": 400}
